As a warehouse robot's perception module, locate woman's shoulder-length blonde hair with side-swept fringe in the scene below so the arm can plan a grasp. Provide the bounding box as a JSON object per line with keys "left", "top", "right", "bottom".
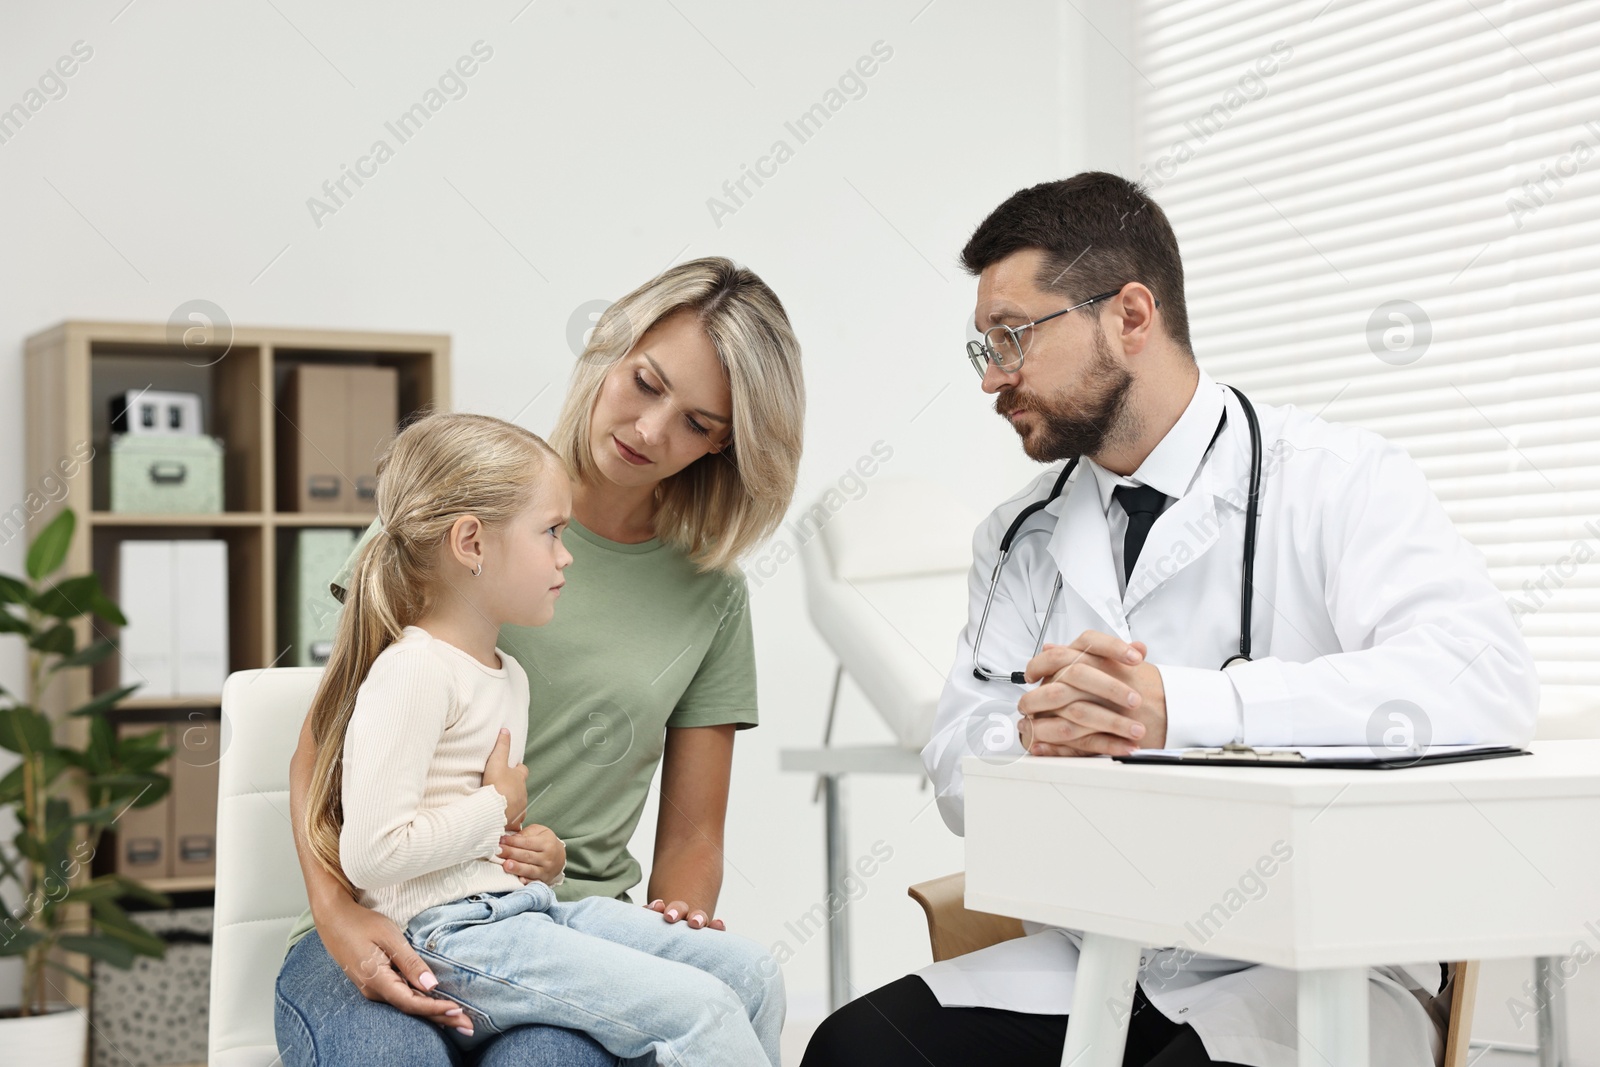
{"left": 550, "top": 256, "right": 805, "bottom": 571}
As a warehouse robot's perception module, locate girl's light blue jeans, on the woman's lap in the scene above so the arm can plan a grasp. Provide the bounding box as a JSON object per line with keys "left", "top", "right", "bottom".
{"left": 405, "top": 881, "right": 784, "bottom": 1067}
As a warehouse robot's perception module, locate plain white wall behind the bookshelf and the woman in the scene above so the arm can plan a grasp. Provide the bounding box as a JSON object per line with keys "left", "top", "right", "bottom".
{"left": 0, "top": 0, "right": 1115, "bottom": 1017}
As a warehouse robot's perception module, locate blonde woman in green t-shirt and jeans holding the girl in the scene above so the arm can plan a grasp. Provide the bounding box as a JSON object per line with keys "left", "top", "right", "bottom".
{"left": 277, "top": 258, "right": 805, "bottom": 1067}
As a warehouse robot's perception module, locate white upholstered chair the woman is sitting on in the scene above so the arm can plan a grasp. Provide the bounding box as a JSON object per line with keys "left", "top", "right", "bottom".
{"left": 208, "top": 667, "right": 322, "bottom": 1067}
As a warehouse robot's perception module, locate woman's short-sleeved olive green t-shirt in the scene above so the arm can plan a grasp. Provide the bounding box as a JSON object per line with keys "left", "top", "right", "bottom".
{"left": 290, "top": 520, "right": 757, "bottom": 945}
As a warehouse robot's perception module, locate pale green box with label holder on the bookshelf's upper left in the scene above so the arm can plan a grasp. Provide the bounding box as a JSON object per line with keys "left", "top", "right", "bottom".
{"left": 94, "top": 434, "right": 222, "bottom": 515}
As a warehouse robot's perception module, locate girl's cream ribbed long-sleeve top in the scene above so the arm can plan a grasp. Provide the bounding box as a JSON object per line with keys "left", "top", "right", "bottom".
{"left": 339, "top": 625, "right": 544, "bottom": 926}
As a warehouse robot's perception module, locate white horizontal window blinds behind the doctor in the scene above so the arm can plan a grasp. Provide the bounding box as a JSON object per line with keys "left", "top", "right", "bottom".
{"left": 1131, "top": 0, "right": 1600, "bottom": 704}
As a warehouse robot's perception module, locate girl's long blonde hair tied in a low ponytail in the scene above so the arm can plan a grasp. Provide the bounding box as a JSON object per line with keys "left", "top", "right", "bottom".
{"left": 302, "top": 414, "right": 570, "bottom": 896}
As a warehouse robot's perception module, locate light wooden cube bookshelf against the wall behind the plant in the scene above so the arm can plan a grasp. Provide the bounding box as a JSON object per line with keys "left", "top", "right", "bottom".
{"left": 24, "top": 322, "right": 450, "bottom": 1030}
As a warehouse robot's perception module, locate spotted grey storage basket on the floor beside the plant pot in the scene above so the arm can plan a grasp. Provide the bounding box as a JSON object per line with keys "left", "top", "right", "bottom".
{"left": 90, "top": 907, "right": 214, "bottom": 1067}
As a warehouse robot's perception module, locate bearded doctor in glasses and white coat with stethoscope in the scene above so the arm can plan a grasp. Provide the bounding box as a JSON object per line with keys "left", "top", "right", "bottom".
{"left": 805, "top": 173, "right": 1538, "bottom": 1067}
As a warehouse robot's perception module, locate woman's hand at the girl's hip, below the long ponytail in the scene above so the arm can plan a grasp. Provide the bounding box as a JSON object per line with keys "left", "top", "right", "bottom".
{"left": 317, "top": 901, "right": 472, "bottom": 1035}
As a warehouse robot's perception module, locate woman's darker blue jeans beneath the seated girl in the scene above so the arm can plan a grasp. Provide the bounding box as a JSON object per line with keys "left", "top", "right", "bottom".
{"left": 277, "top": 931, "right": 618, "bottom": 1067}
